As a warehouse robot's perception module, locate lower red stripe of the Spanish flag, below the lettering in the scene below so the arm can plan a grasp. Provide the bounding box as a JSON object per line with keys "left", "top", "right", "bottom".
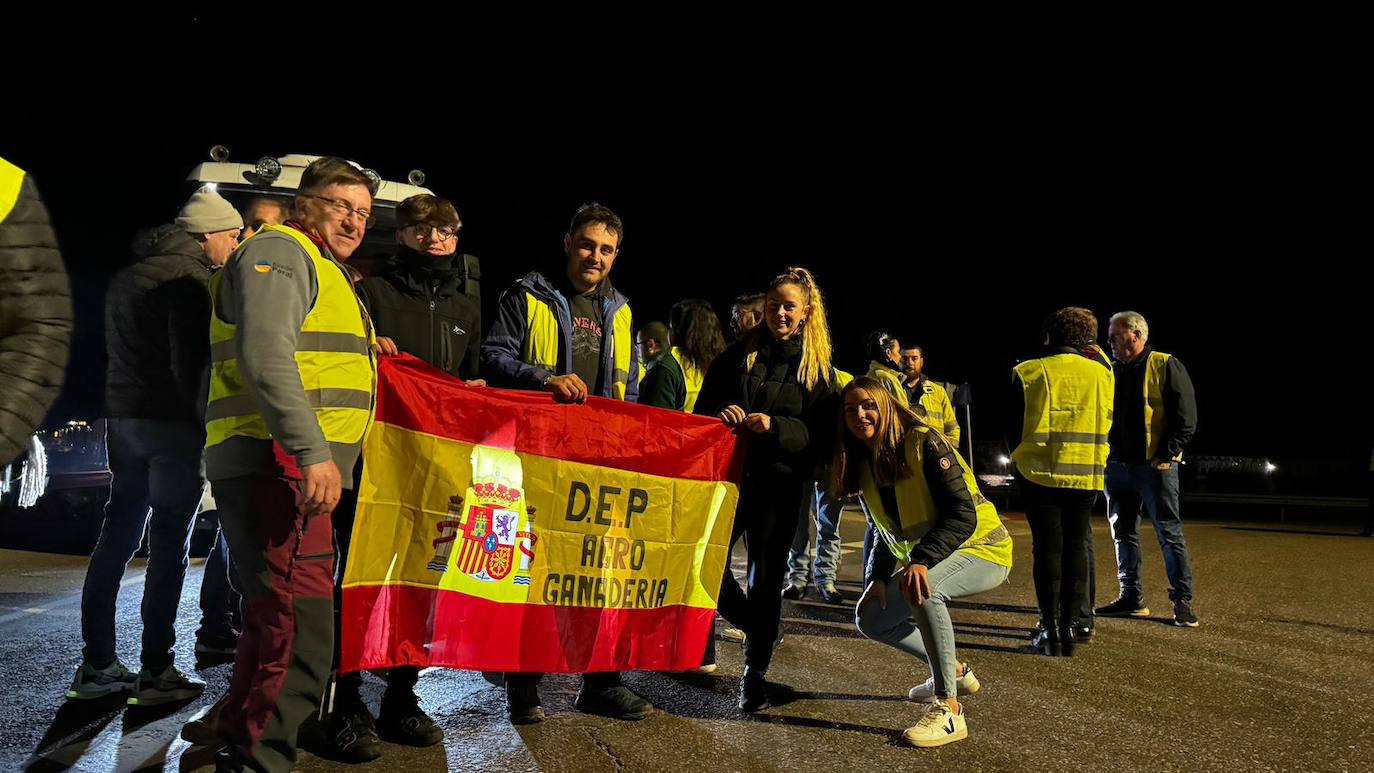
{"left": 341, "top": 585, "right": 716, "bottom": 673}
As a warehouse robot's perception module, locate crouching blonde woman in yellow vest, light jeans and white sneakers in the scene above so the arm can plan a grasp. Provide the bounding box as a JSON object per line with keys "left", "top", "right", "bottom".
{"left": 831, "top": 376, "right": 1011, "bottom": 747}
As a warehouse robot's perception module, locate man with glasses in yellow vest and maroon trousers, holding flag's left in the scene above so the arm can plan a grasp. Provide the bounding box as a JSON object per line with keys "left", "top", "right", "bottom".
{"left": 205, "top": 157, "right": 376, "bottom": 770}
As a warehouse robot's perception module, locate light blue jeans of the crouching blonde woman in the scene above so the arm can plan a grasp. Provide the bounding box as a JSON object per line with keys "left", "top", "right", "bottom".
{"left": 855, "top": 554, "right": 1011, "bottom": 699}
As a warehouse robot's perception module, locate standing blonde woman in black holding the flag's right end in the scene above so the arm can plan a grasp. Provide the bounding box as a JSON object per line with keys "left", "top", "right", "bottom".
{"left": 695, "top": 268, "right": 837, "bottom": 711}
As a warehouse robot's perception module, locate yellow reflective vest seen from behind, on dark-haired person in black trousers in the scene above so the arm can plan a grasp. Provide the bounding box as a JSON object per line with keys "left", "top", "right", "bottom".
{"left": 1011, "top": 354, "right": 1113, "bottom": 492}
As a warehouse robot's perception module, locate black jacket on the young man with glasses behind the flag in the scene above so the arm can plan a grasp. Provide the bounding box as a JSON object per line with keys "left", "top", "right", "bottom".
{"left": 357, "top": 247, "right": 482, "bottom": 379}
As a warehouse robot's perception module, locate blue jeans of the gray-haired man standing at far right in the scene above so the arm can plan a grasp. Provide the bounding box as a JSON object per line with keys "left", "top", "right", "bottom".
{"left": 1106, "top": 461, "right": 1193, "bottom": 601}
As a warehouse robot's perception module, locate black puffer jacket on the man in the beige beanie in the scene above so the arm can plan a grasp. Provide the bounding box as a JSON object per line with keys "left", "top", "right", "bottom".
{"left": 104, "top": 225, "right": 213, "bottom": 424}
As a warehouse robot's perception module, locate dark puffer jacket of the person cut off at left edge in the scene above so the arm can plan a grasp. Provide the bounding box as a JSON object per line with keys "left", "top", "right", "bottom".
{"left": 0, "top": 169, "right": 71, "bottom": 465}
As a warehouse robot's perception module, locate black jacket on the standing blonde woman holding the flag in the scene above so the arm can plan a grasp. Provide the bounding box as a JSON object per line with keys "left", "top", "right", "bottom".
{"left": 692, "top": 335, "right": 840, "bottom": 478}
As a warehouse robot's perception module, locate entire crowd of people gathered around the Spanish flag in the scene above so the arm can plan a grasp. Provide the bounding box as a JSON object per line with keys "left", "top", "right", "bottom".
{"left": 0, "top": 158, "right": 1198, "bottom": 770}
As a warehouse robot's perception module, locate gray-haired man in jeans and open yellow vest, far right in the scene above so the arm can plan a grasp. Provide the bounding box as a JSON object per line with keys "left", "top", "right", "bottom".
{"left": 1096, "top": 312, "right": 1198, "bottom": 627}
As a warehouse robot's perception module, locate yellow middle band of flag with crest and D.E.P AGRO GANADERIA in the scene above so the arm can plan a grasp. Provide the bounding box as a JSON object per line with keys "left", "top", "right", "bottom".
{"left": 344, "top": 423, "right": 739, "bottom": 608}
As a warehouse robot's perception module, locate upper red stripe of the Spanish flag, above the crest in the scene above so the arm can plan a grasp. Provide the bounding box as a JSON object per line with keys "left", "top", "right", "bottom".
{"left": 376, "top": 356, "right": 745, "bottom": 482}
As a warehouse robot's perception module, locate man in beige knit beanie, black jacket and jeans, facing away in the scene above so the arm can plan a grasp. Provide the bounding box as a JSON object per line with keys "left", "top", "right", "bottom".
{"left": 67, "top": 189, "right": 243, "bottom": 706}
